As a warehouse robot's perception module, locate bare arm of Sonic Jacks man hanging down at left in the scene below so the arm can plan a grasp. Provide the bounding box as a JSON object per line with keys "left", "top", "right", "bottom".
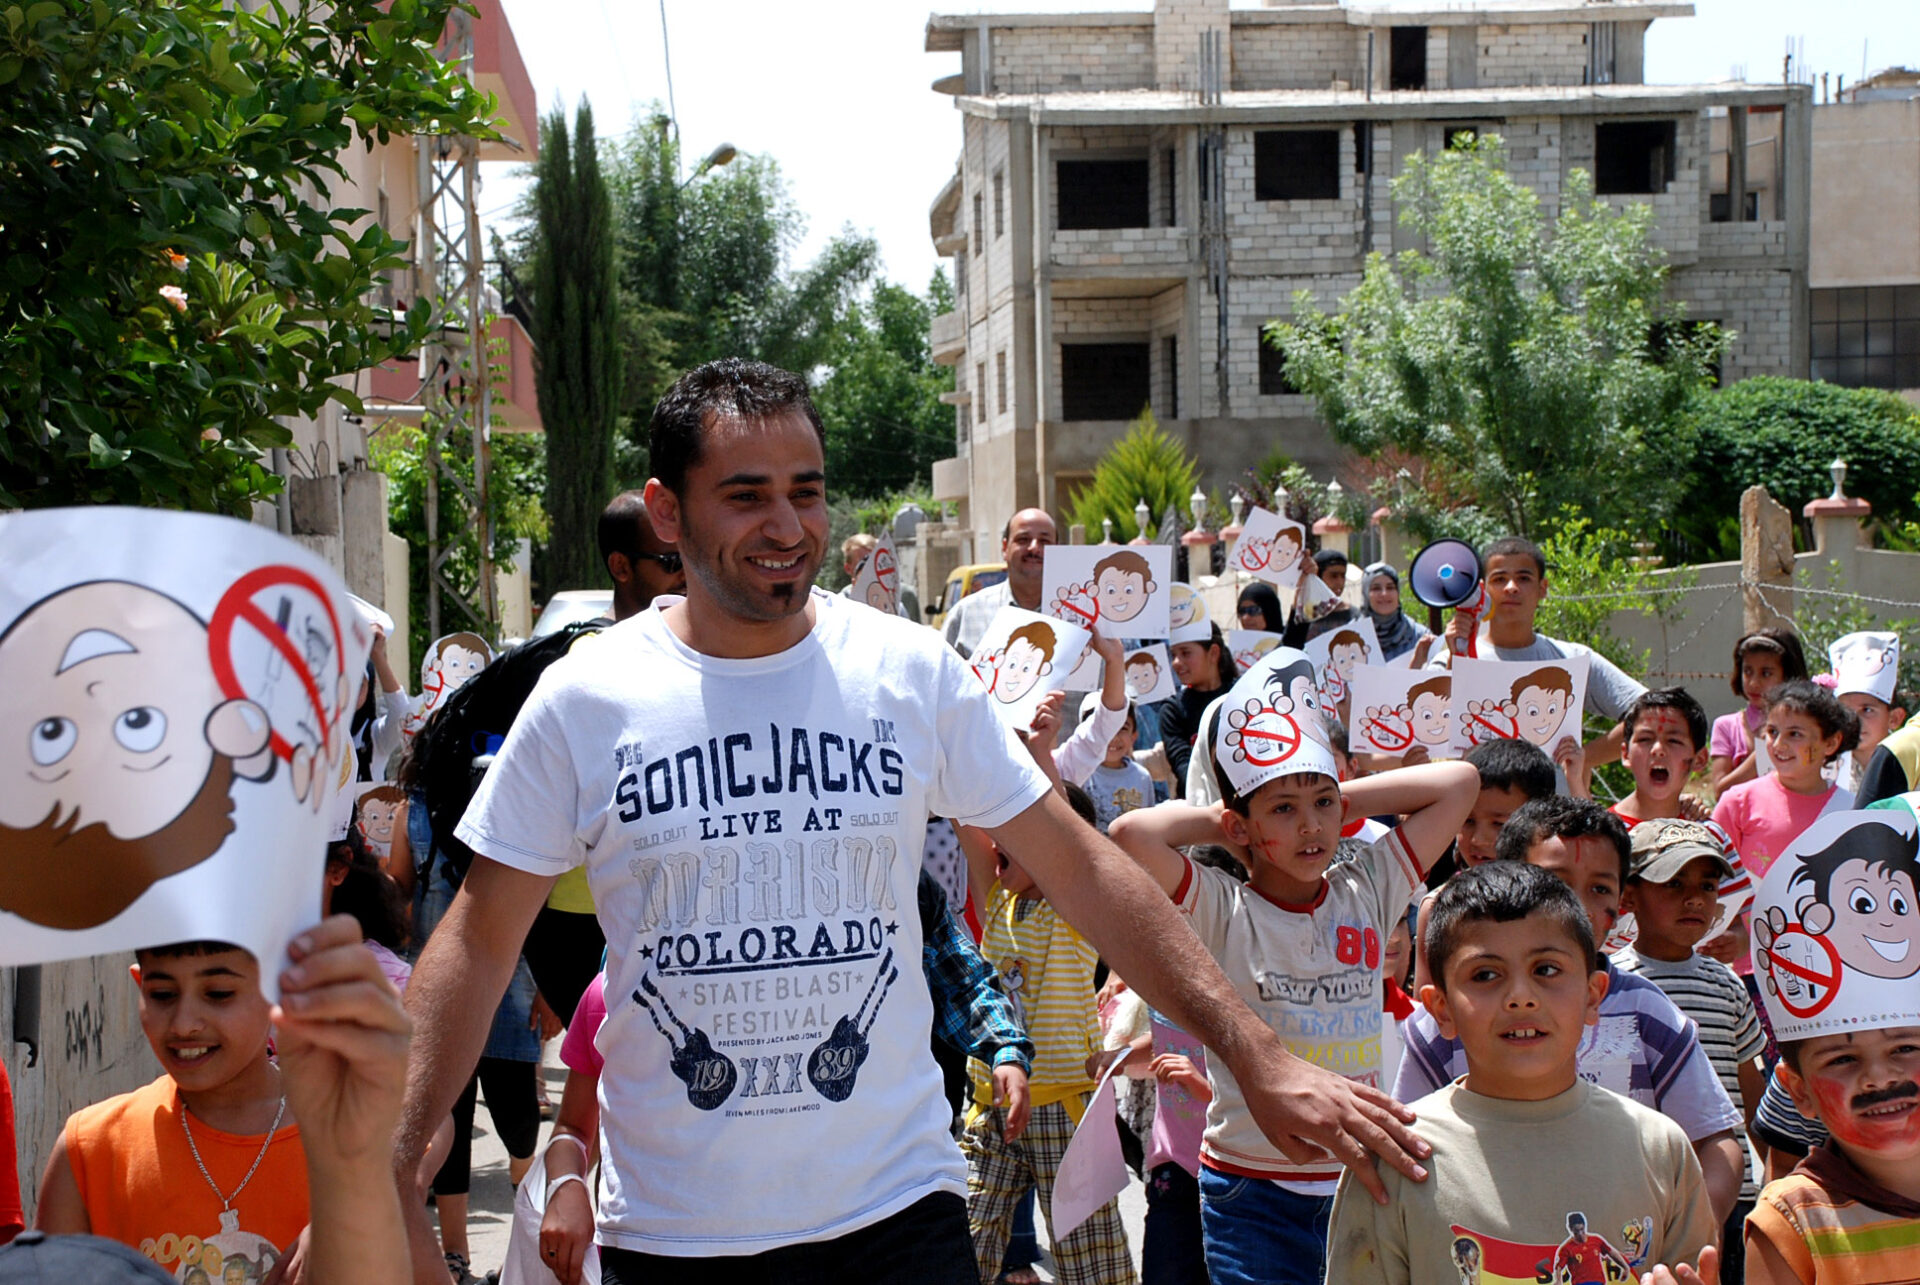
{"left": 394, "top": 857, "right": 553, "bottom": 1285}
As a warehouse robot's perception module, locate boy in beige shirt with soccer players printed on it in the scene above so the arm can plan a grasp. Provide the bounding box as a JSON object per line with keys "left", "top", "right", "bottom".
{"left": 1327, "top": 861, "right": 1716, "bottom": 1285}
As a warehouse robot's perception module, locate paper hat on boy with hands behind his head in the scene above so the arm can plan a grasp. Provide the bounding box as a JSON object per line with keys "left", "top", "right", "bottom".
{"left": 1213, "top": 647, "right": 1340, "bottom": 799}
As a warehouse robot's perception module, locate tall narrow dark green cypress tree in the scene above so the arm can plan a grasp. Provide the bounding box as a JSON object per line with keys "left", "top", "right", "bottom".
{"left": 534, "top": 100, "right": 626, "bottom": 588}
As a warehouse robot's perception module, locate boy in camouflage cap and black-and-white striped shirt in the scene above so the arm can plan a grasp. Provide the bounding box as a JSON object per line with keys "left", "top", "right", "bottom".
{"left": 1613, "top": 820, "right": 1766, "bottom": 1281}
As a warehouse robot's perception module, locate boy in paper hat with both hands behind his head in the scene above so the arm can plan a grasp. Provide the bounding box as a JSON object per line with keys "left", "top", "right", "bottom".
{"left": 1112, "top": 647, "right": 1476, "bottom": 1285}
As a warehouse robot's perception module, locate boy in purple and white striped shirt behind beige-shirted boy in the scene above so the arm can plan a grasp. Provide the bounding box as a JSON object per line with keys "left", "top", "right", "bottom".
{"left": 1394, "top": 795, "right": 1741, "bottom": 1222}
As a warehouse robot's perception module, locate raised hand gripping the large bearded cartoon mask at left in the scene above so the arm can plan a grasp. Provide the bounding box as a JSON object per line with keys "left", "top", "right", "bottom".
{"left": 273, "top": 914, "right": 413, "bottom": 1172}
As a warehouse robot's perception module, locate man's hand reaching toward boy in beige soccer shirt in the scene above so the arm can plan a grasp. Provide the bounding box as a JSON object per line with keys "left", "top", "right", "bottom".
{"left": 1231, "top": 1039, "right": 1432, "bottom": 1204}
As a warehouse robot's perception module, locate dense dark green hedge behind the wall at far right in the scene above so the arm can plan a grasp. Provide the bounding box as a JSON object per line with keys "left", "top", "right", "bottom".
{"left": 1670, "top": 376, "right": 1920, "bottom": 561}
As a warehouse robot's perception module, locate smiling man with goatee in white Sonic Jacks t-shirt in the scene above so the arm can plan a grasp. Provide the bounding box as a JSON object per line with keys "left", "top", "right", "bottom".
{"left": 396, "top": 359, "right": 1423, "bottom": 1285}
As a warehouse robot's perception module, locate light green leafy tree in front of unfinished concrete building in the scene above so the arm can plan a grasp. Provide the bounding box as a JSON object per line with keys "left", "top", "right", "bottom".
{"left": 1269, "top": 134, "right": 1726, "bottom": 534}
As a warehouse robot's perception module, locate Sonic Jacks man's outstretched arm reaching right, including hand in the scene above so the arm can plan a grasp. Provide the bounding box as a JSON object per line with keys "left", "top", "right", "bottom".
{"left": 991, "top": 791, "right": 1430, "bottom": 1200}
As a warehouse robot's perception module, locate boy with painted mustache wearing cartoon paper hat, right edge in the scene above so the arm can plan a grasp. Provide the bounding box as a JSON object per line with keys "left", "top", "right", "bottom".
{"left": 1747, "top": 805, "right": 1920, "bottom": 1285}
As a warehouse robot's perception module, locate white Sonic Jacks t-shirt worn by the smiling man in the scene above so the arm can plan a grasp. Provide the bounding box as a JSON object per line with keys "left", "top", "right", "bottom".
{"left": 459, "top": 592, "right": 1046, "bottom": 1256}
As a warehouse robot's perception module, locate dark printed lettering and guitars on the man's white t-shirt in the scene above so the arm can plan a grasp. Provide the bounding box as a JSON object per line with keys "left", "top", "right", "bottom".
{"left": 614, "top": 718, "right": 904, "bottom": 1116}
